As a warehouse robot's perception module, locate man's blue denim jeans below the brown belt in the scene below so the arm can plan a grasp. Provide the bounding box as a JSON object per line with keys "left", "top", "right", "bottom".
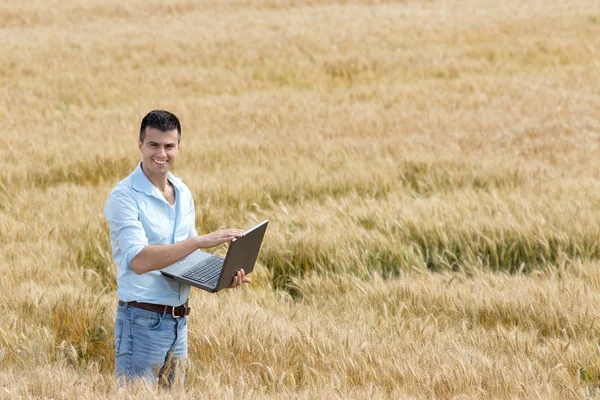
{"left": 115, "top": 303, "right": 187, "bottom": 386}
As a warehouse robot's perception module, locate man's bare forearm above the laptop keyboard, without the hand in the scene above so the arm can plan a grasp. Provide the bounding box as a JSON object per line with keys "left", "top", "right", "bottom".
{"left": 131, "top": 236, "right": 201, "bottom": 275}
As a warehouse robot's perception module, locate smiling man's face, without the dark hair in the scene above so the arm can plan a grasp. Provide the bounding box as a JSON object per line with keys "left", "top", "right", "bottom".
{"left": 138, "top": 128, "right": 179, "bottom": 175}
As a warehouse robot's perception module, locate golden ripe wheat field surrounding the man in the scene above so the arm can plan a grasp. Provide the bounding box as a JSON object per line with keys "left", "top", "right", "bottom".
{"left": 0, "top": 0, "right": 600, "bottom": 399}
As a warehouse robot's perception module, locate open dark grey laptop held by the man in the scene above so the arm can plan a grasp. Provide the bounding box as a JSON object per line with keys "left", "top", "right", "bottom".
{"left": 160, "top": 220, "right": 269, "bottom": 292}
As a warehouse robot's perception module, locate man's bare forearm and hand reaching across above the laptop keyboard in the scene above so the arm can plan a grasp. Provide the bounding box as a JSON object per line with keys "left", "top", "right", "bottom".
{"left": 130, "top": 229, "right": 244, "bottom": 275}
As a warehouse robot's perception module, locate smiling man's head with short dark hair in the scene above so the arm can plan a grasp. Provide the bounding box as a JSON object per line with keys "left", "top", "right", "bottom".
{"left": 138, "top": 110, "right": 181, "bottom": 176}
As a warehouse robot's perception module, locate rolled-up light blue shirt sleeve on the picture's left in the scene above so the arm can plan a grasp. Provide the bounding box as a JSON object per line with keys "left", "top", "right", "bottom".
{"left": 104, "top": 190, "right": 148, "bottom": 268}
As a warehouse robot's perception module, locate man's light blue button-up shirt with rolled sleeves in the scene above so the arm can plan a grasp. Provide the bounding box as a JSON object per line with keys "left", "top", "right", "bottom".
{"left": 104, "top": 164, "right": 197, "bottom": 306}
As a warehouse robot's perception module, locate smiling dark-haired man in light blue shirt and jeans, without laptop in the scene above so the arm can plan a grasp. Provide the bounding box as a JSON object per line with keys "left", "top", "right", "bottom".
{"left": 104, "top": 110, "right": 250, "bottom": 386}
